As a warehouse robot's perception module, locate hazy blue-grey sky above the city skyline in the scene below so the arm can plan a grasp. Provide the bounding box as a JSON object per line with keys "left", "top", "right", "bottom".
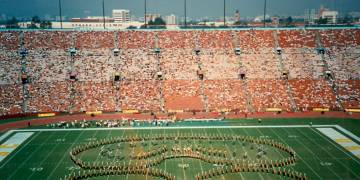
{"left": 0, "top": 0, "right": 360, "bottom": 17}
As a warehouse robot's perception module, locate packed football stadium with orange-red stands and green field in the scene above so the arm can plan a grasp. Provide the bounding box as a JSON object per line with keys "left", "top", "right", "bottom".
{"left": 0, "top": 0, "right": 360, "bottom": 180}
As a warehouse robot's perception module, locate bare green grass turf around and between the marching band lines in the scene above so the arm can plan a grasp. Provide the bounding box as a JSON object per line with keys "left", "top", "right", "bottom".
{"left": 0, "top": 119, "right": 360, "bottom": 180}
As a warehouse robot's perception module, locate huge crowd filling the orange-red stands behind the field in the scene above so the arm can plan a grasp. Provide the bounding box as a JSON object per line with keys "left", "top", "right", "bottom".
{"left": 0, "top": 29, "right": 360, "bottom": 115}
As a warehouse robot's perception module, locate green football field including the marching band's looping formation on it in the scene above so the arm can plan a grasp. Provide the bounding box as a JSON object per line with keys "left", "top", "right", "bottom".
{"left": 0, "top": 119, "right": 360, "bottom": 180}
